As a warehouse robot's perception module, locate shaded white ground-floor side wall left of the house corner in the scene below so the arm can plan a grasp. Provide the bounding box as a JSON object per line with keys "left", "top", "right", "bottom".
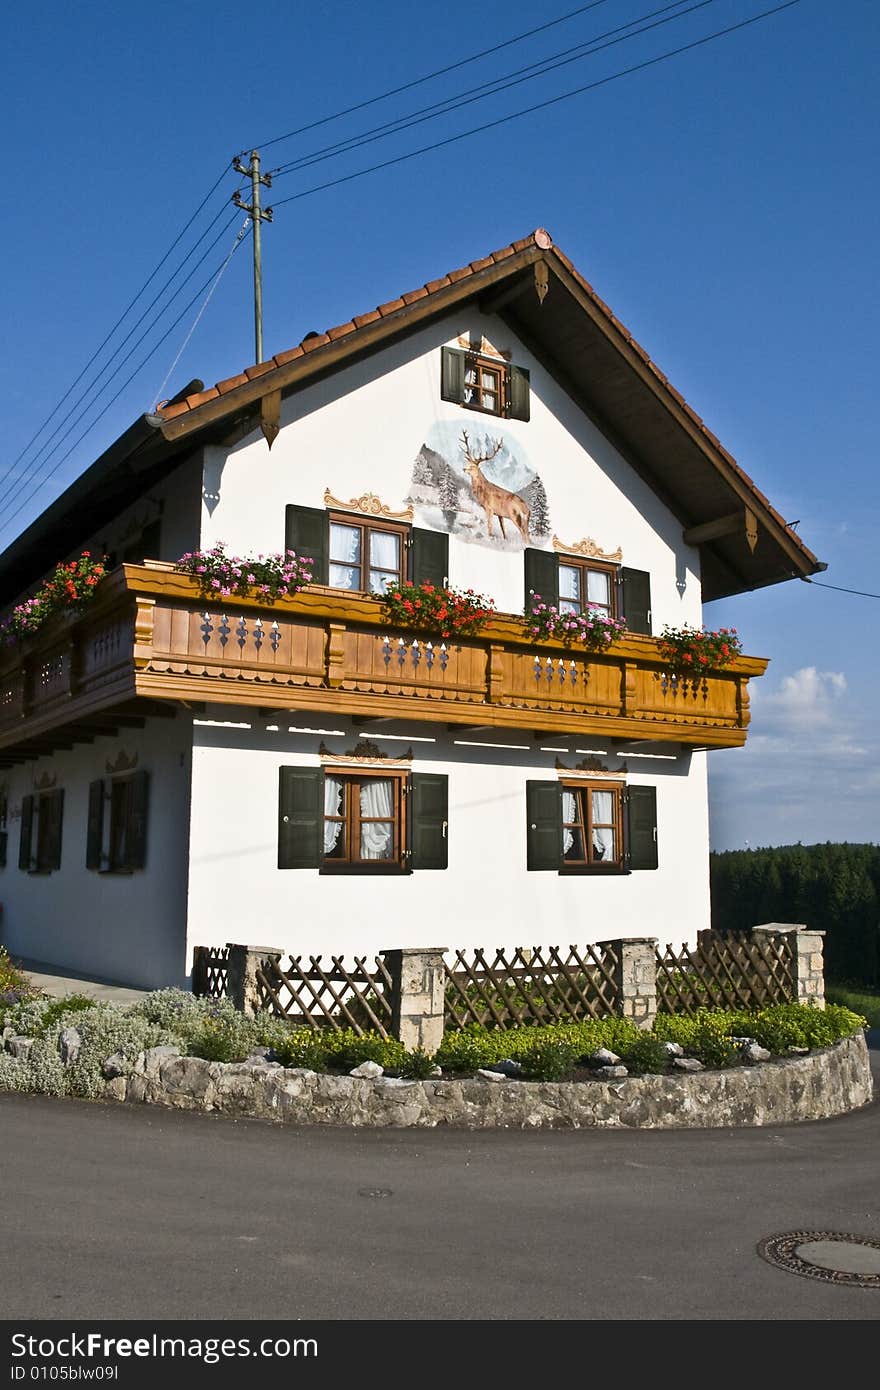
{"left": 0, "top": 717, "right": 192, "bottom": 987}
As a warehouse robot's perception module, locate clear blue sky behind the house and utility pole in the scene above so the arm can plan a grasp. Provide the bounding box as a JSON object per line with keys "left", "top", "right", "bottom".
{"left": 0, "top": 0, "right": 880, "bottom": 848}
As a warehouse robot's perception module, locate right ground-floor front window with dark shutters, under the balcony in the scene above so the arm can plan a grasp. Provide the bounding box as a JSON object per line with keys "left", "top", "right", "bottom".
{"left": 525, "top": 778, "right": 659, "bottom": 874}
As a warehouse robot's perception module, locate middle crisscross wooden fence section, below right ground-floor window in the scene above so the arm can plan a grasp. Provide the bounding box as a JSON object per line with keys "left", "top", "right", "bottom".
{"left": 446, "top": 944, "right": 619, "bottom": 1029}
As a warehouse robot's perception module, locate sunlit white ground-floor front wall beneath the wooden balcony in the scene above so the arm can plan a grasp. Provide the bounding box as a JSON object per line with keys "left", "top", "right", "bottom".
{"left": 188, "top": 708, "right": 709, "bottom": 959}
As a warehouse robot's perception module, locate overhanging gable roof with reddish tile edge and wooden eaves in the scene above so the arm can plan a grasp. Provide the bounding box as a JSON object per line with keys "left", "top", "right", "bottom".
{"left": 0, "top": 228, "right": 824, "bottom": 602}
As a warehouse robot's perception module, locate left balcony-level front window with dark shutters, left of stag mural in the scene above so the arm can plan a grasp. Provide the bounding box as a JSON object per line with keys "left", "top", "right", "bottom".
{"left": 285, "top": 505, "right": 449, "bottom": 594}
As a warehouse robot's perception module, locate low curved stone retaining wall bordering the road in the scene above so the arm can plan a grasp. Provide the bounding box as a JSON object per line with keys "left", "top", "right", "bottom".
{"left": 98, "top": 1033, "right": 873, "bottom": 1129}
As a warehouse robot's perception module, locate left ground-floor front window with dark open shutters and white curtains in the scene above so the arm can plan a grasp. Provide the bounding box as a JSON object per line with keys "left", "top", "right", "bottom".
{"left": 278, "top": 766, "right": 448, "bottom": 873}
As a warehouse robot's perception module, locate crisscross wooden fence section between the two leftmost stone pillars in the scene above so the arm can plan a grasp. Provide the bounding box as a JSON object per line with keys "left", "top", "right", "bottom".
{"left": 256, "top": 955, "right": 392, "bottom": 1037}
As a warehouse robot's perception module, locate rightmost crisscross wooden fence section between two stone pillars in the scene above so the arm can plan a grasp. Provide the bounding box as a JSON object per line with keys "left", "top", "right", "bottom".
{"left": 656, "top": 931, "right": 795, "bottom": 1013}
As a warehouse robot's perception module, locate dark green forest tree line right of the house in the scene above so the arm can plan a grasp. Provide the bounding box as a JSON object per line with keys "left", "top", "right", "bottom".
{"left": 710, "top": 844, "right": 880, "bottom": 990}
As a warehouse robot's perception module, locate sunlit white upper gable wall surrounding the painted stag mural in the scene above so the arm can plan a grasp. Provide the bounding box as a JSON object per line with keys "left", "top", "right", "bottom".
{"left": 202, "top": 309, "right": 701, "bottom": 632}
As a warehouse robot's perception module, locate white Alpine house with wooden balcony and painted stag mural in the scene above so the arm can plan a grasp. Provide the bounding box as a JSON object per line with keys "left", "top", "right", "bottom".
{"left": 0, "top": 231, "right": 822, "bottom": 987}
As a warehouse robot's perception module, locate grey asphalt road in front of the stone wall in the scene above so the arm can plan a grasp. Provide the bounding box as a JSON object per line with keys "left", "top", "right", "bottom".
{"left": 0, "top": 1038, "right": 880, "bottom": 1321}
